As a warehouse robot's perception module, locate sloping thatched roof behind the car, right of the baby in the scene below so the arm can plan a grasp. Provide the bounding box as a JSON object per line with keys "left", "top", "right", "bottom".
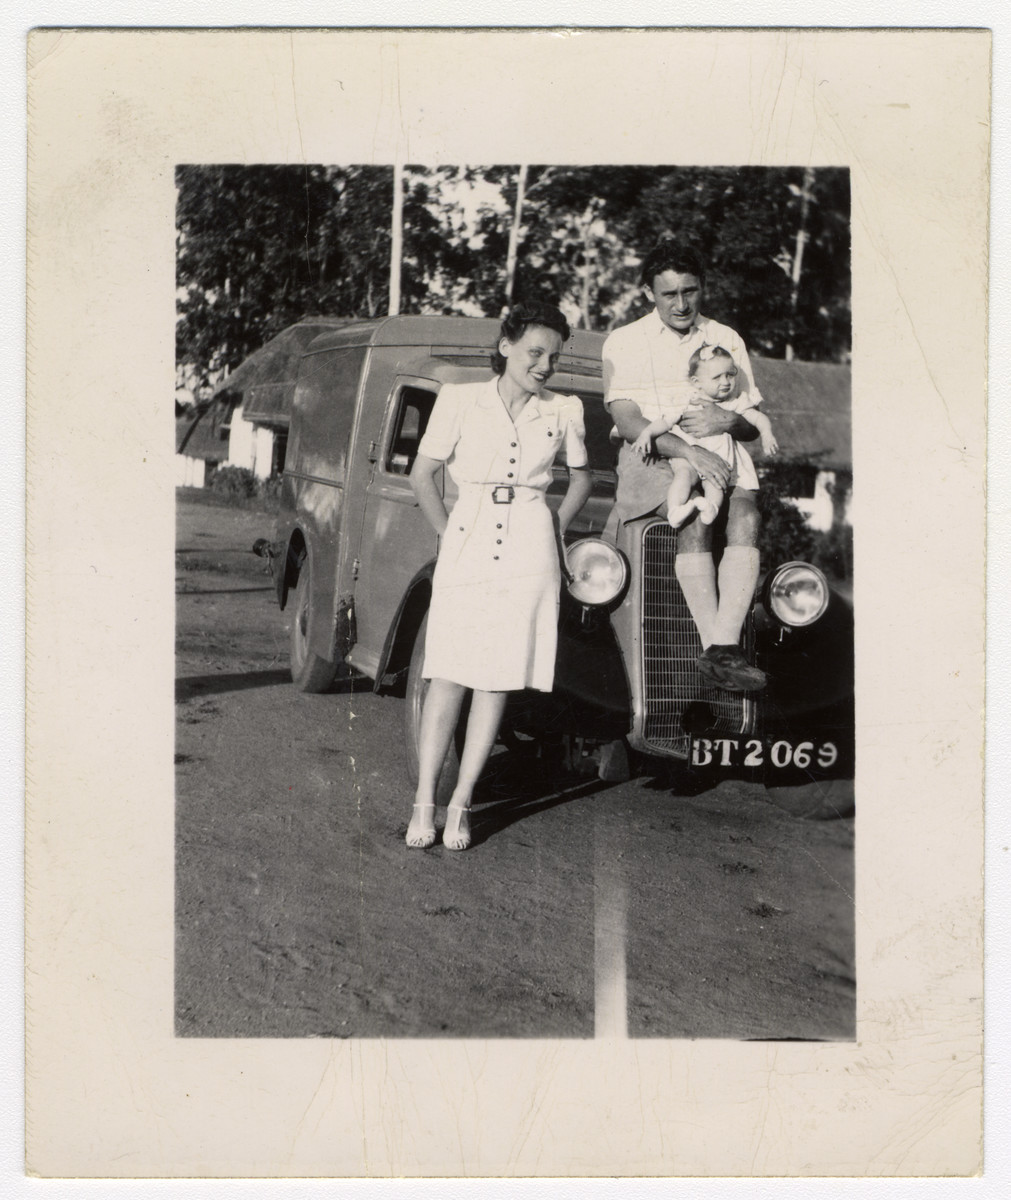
{"left": 748, "top": 354, "right": 853, "bottom": 469}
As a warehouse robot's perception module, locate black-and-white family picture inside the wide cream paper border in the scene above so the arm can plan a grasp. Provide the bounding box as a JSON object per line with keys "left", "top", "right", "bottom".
{"left": 175, "top": 163, "right": 856, "bottom": 1040}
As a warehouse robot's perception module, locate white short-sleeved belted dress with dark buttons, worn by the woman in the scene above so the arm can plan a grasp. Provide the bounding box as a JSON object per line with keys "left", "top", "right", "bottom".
{"left": 418, "top": 377, "right": 586, "bottom": 691}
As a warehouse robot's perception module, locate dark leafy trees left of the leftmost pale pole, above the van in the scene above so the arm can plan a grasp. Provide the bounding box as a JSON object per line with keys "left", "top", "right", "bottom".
{"left": 175, "top": 166, "right": 393, "bottom": 386}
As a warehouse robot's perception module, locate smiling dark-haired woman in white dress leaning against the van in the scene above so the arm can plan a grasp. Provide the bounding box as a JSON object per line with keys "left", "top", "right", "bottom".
{"left": 407, "top": 305, "right": 592, "bottom": 850}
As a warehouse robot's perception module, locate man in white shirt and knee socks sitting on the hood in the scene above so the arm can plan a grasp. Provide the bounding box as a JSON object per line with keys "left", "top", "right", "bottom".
{"left": 603, "top": 240, "right": 765, "bottom": 691}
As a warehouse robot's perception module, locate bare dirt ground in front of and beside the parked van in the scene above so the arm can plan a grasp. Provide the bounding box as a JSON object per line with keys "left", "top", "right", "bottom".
{"left": 175, "top": 491, "right": 855, "bottom": 1038}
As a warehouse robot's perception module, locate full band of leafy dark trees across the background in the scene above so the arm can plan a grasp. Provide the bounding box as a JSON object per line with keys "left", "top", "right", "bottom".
{"left": 177, "top": 164, "right": 850, "bottom": 388}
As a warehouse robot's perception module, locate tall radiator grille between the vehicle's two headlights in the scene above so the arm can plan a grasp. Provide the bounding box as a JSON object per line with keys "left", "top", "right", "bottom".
{"left": 641, "top": 521, "right": 747, "bottom": 757}
